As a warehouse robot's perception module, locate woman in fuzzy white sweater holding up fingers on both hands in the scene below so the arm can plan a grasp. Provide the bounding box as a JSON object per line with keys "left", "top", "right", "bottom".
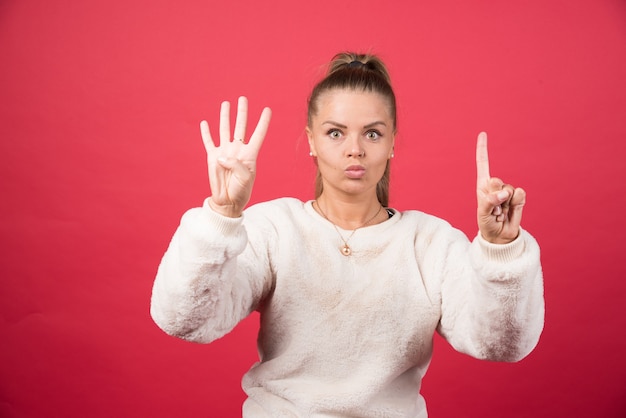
{"left": 151, "top": 53, "right": 544, "bottom": 418}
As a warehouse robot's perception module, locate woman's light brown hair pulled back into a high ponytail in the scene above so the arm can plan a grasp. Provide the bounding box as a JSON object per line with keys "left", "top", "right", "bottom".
{"left": 307, "top": 52, "right": 397, "bottom": 206}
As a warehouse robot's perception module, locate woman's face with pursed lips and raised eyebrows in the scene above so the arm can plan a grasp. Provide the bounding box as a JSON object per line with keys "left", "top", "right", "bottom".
{"left": 306, "top": 90, "right": 395, "bottom": 196}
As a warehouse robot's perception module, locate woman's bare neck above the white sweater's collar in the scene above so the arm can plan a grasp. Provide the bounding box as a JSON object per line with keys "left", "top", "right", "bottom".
{"left": 315, "top": 193, "right": 386, "bottom": 230}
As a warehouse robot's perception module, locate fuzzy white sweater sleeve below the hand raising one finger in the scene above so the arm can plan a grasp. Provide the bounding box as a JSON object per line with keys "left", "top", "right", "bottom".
{"left": 438, "top": 229, "right": 544, "bottom": 361}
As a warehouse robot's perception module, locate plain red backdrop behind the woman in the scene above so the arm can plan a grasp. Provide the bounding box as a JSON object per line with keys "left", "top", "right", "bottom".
{"left": 0, "top": 0, "right": 626, "bottom": 418}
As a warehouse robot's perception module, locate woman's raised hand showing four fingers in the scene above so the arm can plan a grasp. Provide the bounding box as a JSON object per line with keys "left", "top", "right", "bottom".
{"left": 200, "top": 97, "right": 272, "bottom": 218}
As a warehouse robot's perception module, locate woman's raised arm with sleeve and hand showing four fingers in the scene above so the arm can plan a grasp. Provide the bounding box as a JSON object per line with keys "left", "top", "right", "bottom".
{"left": 150, "top": 97, "right": 270, "bottom": 342}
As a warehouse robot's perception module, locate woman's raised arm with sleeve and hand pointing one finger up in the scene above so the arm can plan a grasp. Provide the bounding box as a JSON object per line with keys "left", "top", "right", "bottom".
{"left": 439, "top": 133, "right": 544, "bottom": 361}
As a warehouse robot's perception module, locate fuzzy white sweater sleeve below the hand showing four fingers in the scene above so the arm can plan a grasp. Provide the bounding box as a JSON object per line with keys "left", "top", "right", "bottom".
{"left": 150, "top": 199, "right": 270, "bottom": 343}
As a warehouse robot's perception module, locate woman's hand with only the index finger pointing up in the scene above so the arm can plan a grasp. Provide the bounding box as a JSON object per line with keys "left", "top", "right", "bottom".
{"left": 476, "top": 132, "right": 526, "bottom": 244}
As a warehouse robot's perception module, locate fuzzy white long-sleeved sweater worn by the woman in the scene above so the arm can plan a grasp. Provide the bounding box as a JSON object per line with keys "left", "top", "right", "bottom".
{"left": 151, "top": 198, "right": 544, "bottom": 418}
